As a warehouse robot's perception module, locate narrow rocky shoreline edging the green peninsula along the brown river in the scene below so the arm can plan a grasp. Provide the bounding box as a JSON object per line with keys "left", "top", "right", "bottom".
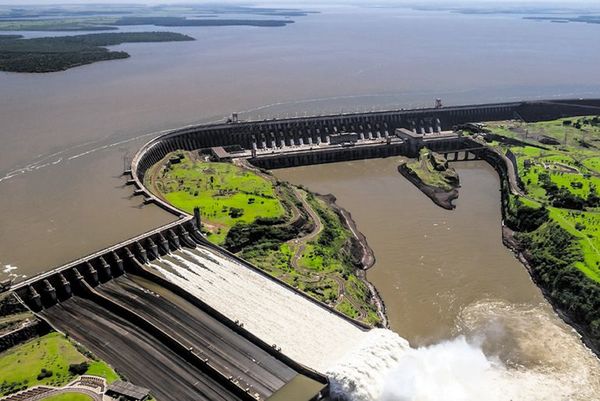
{"left": 315, "top": 193, "right": 389, "bottom": 328}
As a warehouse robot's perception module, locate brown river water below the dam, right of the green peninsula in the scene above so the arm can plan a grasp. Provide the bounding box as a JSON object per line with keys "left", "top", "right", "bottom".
{"left": 274, "top": 157, "right": 600, "bottom": 399}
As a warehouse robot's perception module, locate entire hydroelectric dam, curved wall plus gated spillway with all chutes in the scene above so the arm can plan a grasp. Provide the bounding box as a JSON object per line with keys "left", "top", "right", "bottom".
{"left": 4, "top": 99, "right": 600, "bottom": 401}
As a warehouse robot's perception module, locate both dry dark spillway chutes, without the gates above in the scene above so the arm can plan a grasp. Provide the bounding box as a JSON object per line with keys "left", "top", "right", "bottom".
{"left": 41, "top": 274, "right": 323, "bottom": 401}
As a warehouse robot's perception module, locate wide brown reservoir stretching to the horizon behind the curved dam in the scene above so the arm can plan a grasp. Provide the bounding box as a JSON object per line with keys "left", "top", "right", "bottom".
{"left": 0, "top": 7, "right": 600, "bottom": 282}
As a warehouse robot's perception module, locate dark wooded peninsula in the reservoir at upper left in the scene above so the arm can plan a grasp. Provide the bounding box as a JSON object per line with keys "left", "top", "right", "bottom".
{"left": 0, "top": 32, "right": 194, "bottom": 73}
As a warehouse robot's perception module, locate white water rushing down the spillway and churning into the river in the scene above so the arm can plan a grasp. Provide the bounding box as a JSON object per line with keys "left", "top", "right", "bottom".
{"left": 146, "top": 244, "right": 600, "bottom": 401}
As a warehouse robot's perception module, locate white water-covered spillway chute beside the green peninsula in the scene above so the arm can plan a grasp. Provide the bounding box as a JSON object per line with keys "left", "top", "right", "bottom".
{"left": 150, "top": 246, "right": 367, "bottom": 372}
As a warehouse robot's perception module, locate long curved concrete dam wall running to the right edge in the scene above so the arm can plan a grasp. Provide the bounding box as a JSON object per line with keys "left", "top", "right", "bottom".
{"left": 132, "top": 99, "right": 600, "bottom": 188}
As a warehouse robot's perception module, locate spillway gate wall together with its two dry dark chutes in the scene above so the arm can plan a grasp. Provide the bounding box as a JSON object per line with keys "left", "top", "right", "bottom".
{"left": 13, "top": 218, "right": 328, "bottom": 401}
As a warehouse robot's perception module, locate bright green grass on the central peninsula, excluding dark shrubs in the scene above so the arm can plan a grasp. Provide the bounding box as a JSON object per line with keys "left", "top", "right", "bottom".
{"left": 151, "top": 151, "right": 379, "bottom": 324}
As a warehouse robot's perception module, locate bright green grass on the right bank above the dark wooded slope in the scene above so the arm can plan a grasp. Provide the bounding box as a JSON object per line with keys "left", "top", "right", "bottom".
{"left": 487, "top": 117, "right": 600, "bottom": 282}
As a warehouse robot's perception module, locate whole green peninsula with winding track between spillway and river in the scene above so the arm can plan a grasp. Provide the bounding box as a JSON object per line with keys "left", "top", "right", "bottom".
{"left": 145, "top": 151, "right": 385, "bottom": 325}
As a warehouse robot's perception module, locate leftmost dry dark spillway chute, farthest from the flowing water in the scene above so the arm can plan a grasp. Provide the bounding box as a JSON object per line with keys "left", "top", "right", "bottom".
{"left": 42, "top": 297, "right": 239, "bottom": 401}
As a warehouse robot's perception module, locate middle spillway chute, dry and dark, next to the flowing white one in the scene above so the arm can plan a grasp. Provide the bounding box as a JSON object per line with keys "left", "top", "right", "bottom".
{"left": 99, "top": 275, "right": 297, "bottom": 399}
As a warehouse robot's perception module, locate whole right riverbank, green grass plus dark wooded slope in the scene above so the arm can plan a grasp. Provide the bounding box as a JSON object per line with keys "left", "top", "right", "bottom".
{"left": 487, "top": 117, "right": 600, "bottom": 347}
